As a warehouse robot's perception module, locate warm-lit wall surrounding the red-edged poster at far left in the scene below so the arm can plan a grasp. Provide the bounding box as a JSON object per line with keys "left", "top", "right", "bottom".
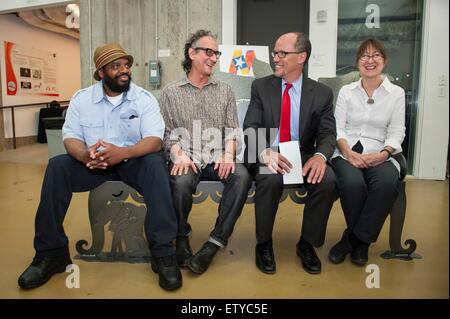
{"left": 0, "top": 14, "right": 81, "bottom": 138}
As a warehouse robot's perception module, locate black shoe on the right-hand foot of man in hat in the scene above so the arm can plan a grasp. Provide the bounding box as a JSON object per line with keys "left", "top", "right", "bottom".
{"left": 151, "top": 255, "right": 183, "bottom": 291}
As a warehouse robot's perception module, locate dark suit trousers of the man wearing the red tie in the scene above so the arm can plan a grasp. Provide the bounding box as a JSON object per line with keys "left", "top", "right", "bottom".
{"left": 252, "top": 152, "right": 337, "bottom": 247}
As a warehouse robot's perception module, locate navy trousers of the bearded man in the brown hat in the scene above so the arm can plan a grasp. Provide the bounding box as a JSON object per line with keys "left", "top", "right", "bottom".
{"left": 34, "top": 152, "right": 177, "bottom": 257}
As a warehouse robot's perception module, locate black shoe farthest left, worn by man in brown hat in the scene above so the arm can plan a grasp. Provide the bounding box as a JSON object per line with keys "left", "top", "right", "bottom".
{"left": 18, "top": 254, "right": 72, "bottom": 289}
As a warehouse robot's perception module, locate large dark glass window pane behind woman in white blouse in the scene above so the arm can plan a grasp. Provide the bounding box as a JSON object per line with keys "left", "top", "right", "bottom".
{"left": 336, "top": 0, "right": 423, "bottom": 173}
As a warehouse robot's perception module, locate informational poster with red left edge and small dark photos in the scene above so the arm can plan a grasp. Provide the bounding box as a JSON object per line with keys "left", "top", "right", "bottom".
{"left": 4, "top": 41, "right": 59, "bottom": 96}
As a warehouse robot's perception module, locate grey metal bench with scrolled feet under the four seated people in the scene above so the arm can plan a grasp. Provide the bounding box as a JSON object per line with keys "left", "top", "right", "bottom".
{"left": 75, "top": 154, "right": 421, "bottom": 263}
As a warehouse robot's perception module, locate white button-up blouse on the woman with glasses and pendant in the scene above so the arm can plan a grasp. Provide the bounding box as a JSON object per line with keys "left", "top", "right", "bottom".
{"left": 333, "top": 77, "right": 406, "bottom": 174}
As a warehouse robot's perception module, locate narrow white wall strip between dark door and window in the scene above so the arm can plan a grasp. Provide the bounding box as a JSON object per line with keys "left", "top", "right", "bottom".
{"left": 308, "top": 0, "right": 338, "bottom": 80}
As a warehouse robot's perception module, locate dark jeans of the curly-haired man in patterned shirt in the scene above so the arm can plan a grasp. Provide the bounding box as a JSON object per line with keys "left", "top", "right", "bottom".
{"left": 169, "top": 164, "right": 252, "bottom": 246}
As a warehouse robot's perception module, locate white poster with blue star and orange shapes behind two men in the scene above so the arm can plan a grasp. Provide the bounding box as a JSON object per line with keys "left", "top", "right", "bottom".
{"left": 219, "top": 45, "right": 270, "bottom": 76}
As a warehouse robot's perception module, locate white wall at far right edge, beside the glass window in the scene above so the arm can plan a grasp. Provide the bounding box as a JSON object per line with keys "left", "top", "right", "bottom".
{"left": 414, "top": 0, "right": 449, "bottom": 180}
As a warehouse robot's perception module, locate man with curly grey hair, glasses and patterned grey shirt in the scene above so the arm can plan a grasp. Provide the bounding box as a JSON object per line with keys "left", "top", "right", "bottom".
{"left": 160, "top": 30, "right": 251, "bottom": 274}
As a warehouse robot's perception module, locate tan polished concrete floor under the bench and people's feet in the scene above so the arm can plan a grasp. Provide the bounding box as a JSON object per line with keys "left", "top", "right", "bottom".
{"left": 0, "top": 144, "right": 449, "bottom": 299}
